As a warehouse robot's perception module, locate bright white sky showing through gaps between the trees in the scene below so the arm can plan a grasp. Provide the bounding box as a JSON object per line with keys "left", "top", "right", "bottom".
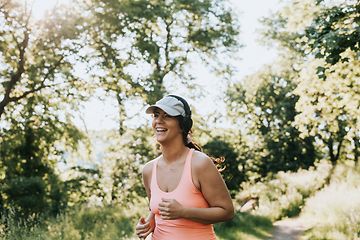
{"left": 33, "top": 0, "right": 279, "bottom": 130}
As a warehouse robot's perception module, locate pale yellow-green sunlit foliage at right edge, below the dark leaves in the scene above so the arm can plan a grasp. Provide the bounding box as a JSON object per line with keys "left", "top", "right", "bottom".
{"left": 295, "top": 50, "right": 360, "bottom": 165}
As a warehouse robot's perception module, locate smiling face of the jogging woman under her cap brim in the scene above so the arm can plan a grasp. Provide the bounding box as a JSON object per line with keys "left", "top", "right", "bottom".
{"left": 152, "top": 109, "right": 182, "bottom": 143}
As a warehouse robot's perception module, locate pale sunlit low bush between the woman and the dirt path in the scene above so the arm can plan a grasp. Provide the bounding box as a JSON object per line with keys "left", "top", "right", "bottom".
{"left": 236, "top": 162, "right": 331, "bottom": 221}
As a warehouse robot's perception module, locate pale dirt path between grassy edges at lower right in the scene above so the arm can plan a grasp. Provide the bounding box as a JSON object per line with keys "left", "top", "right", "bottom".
{"left": 272, "top": 218, "right": 306, "bottom": 240}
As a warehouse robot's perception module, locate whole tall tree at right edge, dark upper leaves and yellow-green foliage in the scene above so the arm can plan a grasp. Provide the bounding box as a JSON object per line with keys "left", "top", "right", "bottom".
{"left": 265, "top": 0, "right": 360, "bottom": 165}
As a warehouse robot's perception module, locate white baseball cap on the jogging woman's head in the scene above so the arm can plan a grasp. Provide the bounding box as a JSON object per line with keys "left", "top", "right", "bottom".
{"left": 146, "top": 96, "right": 186, "bottom": 117}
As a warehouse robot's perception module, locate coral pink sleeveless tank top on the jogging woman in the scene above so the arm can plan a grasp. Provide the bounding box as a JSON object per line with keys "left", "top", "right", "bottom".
{"left": 150, "top": 149, "right": 216, "bottom": 240}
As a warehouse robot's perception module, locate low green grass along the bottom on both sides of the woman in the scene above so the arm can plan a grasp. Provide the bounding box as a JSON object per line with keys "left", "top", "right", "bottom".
{"left": 0, "top": 206, "right": 272, "bottom": 240}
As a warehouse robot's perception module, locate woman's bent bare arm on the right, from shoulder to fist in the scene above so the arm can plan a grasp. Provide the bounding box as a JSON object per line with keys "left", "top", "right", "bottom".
{"left": 159, "top": 154, "right": 234, "bottom": 224}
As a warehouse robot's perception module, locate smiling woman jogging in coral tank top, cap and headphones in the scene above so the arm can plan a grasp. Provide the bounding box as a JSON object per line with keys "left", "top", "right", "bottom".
{"left": 136, "top": 95, "right": 234, "bottom": 240}
